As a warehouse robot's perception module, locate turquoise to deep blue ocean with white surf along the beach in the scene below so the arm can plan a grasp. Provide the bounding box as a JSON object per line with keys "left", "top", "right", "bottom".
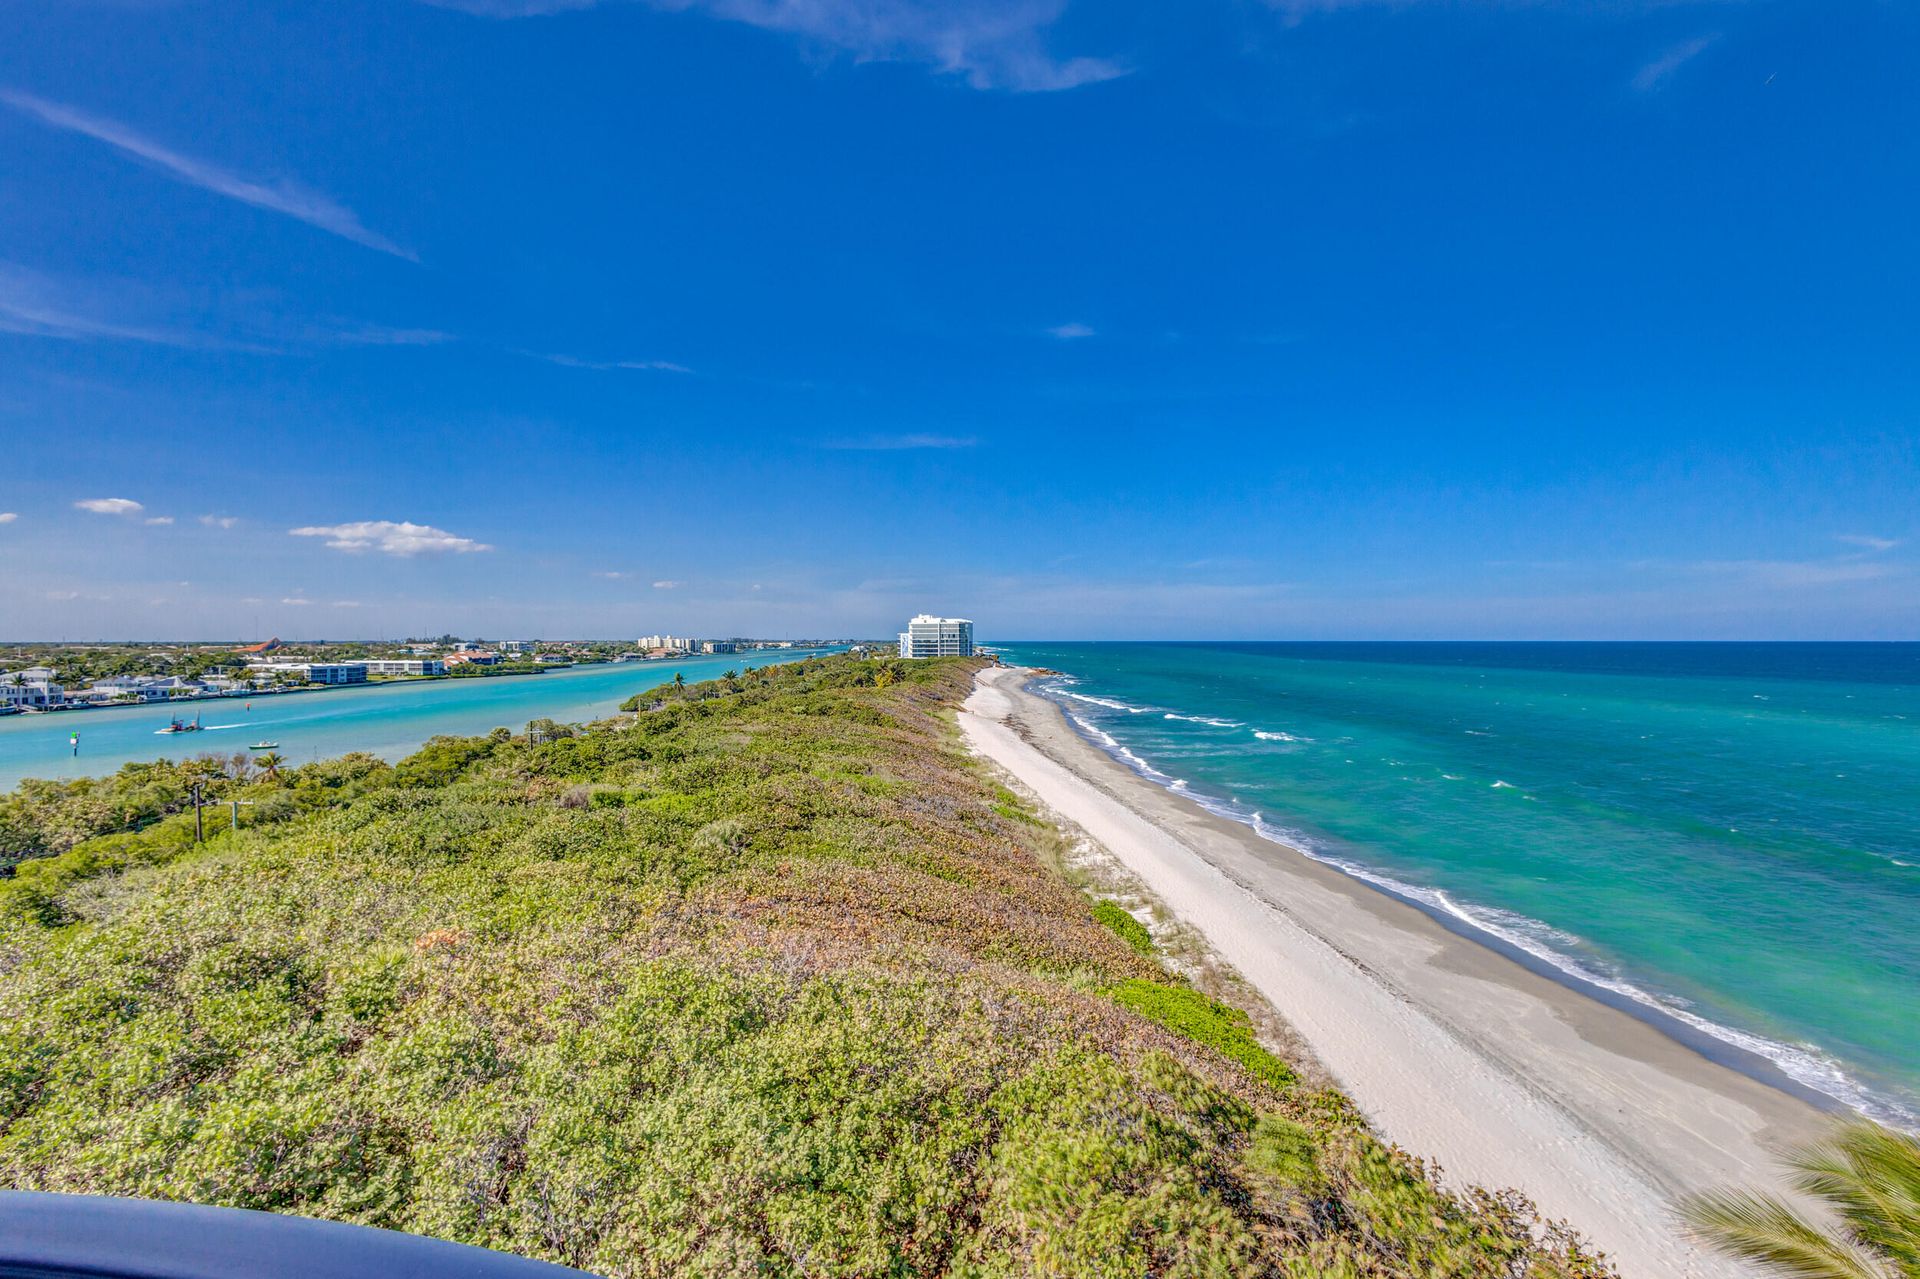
{"left": 1000, "top": 643, "right": 1920, "bottom": 1127}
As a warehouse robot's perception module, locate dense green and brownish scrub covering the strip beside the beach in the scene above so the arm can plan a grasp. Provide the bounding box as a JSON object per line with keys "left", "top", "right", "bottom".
{"left": 0, "top": 657, "right": 1605, "bottom": 1279}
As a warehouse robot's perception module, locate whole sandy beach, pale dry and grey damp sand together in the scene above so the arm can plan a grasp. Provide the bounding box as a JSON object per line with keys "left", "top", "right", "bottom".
{"left": 960, "top": 668, "right": 1828, "bottom": 1277}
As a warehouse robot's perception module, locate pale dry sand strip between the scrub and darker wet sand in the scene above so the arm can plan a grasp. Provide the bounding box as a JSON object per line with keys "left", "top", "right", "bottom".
{"left": 958, "top": 668, "right": 1745, "bottom": 1279}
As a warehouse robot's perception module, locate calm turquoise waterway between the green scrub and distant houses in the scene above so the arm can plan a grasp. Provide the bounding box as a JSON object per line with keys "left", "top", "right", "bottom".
{"left": 0, "top": 649, "right": 833, "bottom": 789}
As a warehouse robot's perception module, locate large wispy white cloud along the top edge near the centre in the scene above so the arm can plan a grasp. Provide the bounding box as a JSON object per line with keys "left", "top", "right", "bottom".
{"left": 428, "top": 0, "right": 1127, "bottom": 92}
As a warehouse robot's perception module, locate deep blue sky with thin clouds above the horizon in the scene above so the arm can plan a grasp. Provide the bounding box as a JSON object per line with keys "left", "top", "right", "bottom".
{"left": 0, "top": 0, "right": 1920, "bottom": 638}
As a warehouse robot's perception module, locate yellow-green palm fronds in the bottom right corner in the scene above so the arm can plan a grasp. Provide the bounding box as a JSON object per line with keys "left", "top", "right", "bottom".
{"left": 1682, "top": 1122, "right": 1920, "bottom": 1279}
